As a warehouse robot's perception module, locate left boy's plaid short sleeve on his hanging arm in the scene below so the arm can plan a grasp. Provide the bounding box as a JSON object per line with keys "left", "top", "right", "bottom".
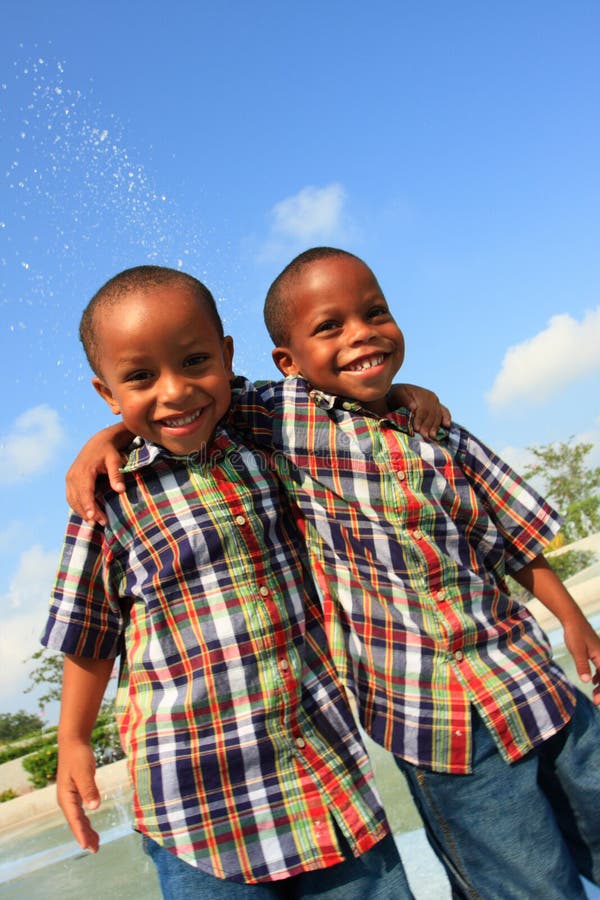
{"left": 41, "top": 513, "right": 124, "bottom": 659}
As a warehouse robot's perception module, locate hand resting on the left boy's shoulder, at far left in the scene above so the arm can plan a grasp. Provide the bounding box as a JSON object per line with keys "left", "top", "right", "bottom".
{"left": 66, "top": 423, "right": 133, "bottom": 525}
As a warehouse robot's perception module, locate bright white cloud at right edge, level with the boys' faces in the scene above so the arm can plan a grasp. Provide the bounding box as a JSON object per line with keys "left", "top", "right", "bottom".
{"left": 486, "top": 306, "right": 600, "bottom": 409}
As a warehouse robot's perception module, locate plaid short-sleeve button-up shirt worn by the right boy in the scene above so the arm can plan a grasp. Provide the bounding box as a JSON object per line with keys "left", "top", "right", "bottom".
{"left": 231, "top": 378, "right": 574, "bottom": 773}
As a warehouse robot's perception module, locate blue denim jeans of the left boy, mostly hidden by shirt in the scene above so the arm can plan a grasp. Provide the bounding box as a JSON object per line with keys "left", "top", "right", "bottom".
{"left": 143, "top": 835, "right": 413, "bottom": 900}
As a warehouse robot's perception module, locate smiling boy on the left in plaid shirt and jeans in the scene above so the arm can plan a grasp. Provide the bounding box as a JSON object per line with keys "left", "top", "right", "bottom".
{"left": 43, "top": 266, "right": 412, "bottom": 900}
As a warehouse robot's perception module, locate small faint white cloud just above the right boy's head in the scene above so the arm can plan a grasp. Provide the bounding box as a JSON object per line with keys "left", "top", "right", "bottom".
{"left": 261, "top": 183, "right": 346, "bottom": 258}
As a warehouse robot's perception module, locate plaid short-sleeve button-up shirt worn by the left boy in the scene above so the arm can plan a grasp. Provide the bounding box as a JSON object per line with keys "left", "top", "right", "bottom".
{"left": 43, "top": 430, "right": 387, "bottom": 882}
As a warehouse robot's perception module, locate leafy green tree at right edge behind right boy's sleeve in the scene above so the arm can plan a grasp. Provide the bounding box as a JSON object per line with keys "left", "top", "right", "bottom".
{"left": 523, "top": 437, "right": 600, "bottom": 580}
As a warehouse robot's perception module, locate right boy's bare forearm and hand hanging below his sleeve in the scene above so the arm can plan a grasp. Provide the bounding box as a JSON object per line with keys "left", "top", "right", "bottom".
{"left": 512, "top": 554, "right": 600, "bottom": 705}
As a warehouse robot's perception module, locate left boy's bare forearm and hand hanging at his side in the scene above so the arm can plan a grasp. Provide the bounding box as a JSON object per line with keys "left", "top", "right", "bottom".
{"left": 56, "top": 655, "right": 114, "bottom": 853}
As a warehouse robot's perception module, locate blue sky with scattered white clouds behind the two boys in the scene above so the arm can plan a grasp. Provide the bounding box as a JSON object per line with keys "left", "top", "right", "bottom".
{"left": 0, "top": 0, "right": 600, "bottom": 712}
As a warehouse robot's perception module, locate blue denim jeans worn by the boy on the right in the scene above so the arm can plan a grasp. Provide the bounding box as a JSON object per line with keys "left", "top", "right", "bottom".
{"left": 396, "top": 692, "right": 600, "bottom": 900}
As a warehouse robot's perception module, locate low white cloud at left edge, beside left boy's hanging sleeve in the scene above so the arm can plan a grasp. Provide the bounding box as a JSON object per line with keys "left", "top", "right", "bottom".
{"left": 0, "top": 544, "right": 58, "bottom": 712}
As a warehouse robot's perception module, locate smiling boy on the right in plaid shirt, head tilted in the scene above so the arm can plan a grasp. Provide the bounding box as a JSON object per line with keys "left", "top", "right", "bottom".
{"left": 253, "top": 248, "right": 600, "bottom": 900}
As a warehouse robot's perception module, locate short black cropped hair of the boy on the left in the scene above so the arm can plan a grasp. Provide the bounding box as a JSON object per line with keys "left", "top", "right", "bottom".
{"left": 79, "top": 266, "right": 224, "bottom": 375}
